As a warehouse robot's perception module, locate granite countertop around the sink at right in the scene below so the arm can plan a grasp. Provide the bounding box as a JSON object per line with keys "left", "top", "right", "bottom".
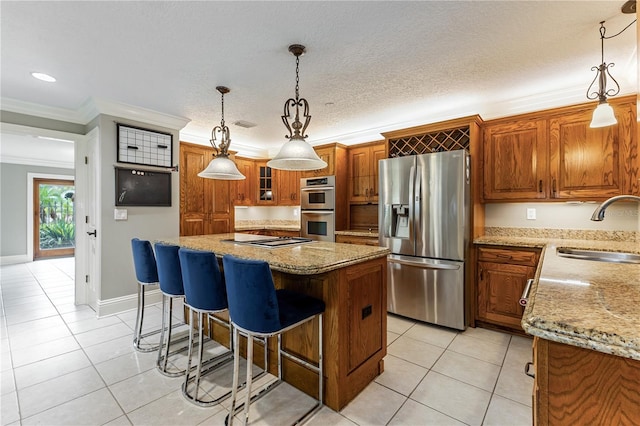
{"left": 474, "top": 236, "right": 640, "bottom": 360}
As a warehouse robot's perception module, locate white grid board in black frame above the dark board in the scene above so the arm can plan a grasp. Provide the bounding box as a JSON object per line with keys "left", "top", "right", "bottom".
{"left": 117, "top": 123, "right": 173, "bottom": 167}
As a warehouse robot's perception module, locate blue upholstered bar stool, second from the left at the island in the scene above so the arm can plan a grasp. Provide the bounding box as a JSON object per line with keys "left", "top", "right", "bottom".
{"left": 155, "top": 243, "right": 188, "bottom": 377}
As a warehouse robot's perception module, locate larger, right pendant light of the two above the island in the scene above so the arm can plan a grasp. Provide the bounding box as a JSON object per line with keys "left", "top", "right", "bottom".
{"left": 267, "top": 44, "right": 327, "bottom": 171}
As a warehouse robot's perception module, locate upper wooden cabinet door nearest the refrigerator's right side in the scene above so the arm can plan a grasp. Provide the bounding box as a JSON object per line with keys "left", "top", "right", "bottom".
{"left": 483, "top": 120, "right": 549, "bottom": 201}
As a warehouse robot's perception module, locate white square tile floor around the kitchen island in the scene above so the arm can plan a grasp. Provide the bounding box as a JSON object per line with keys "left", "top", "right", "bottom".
{"left": 0, "top": 258, "right": 532, "bottom": 426}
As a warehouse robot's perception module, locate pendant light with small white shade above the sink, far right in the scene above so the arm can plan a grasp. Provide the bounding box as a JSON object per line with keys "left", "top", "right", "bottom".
{"left": 587, "top": 19, "right": 636, "bottom": 128}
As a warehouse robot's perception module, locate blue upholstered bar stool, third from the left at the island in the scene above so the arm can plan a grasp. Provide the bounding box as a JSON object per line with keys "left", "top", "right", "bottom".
{"left": 178, "top": 248, "right": 233, "bottom": 407}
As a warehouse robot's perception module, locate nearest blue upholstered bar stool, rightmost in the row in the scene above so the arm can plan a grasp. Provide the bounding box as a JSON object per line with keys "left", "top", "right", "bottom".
{"left": 222, "top": 255, "right": 325, "bottom": 426}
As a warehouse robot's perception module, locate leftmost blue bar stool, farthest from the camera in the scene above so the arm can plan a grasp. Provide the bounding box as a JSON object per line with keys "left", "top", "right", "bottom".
{"left": 131, "top": 238, "right": 160, "bottom": 352}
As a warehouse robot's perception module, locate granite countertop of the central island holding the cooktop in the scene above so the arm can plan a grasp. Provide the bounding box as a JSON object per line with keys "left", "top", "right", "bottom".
{"left": 157, "top": 233, "right": 389, "bottom": 275}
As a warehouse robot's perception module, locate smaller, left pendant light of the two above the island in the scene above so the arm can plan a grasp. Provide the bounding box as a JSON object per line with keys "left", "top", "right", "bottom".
{"left": 198, "top": 86, "right": 246, "bottom": 180}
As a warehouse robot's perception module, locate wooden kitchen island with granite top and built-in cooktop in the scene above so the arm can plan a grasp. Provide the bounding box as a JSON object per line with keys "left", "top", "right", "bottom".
{"left": 158, "top": 233, "right": 389, "bottom": 411}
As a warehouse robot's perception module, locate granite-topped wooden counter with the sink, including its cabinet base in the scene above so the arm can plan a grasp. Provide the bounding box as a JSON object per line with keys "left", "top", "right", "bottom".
{"left": 474, "top": 237, "right": 640, "bottom": 425}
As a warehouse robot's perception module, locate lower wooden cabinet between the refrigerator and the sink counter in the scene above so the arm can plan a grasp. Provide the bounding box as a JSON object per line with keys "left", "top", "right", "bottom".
{"left": 476, "top": 246, "right": 540, "bottom": 333}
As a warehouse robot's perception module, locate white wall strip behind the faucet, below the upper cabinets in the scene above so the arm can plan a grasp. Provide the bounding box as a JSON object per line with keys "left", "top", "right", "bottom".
{"left": 485, "top": 202, "right": 640, "bottom": 231}
